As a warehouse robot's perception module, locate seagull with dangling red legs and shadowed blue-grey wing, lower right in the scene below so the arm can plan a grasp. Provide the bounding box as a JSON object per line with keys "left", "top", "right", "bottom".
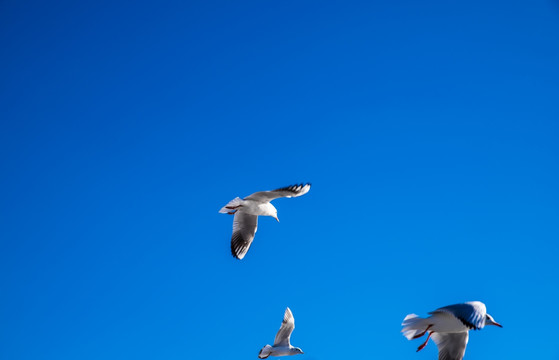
{"left": 402, "top": 301, "right": 503, "bottom": 360}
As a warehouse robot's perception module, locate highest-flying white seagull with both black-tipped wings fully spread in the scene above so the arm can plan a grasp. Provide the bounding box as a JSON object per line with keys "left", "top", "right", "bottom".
{"left": 219, "top": 184, "right": 311, "bottom": 260}
